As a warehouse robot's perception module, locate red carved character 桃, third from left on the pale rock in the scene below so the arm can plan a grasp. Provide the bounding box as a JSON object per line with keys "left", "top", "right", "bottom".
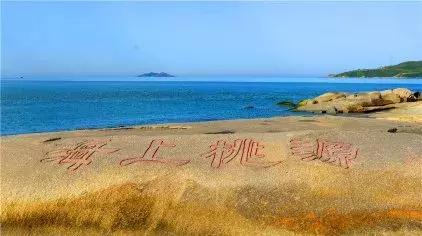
{"left": 201, "top": 139, "right": 280, "bottom": 168}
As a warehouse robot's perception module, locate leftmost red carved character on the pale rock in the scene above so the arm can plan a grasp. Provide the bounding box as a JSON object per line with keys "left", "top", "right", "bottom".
{"left": 41, "top": 140, "right": 119, "bottom": 171}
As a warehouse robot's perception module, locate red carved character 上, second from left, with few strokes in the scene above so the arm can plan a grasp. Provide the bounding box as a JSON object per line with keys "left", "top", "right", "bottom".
{"left": 120, "top": 139, "right": 190, "bottom": 166}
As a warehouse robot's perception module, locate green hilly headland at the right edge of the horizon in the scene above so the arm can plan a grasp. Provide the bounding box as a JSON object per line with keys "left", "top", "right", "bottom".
{"left": 330, "top": 61, "right": 422, "bottom": 78}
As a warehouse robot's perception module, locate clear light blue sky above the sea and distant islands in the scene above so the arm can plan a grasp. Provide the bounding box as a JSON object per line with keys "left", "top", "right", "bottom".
{"left": 1, "top": 1, "right": 422, "bottom": 77}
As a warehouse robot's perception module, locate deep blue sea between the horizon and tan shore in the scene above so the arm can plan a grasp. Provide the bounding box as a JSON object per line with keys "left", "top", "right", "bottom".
{"left": 1, "top": 79, "right": 422, "bottom": 135}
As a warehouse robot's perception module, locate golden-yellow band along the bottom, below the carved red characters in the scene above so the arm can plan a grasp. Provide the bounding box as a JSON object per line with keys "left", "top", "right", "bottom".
{"left": 1, "top": 177, "right": 422, "bottom": 235}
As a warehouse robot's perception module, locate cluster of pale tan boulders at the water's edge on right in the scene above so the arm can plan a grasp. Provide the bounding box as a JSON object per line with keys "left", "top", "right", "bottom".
{"left": 296, "top": 88, "right": 422, "bottom": 114}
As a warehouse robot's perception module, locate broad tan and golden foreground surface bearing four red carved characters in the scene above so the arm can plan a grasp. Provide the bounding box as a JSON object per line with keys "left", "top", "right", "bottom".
{"left": 1, "top": 114, "right": 422, "bottom": 235}
